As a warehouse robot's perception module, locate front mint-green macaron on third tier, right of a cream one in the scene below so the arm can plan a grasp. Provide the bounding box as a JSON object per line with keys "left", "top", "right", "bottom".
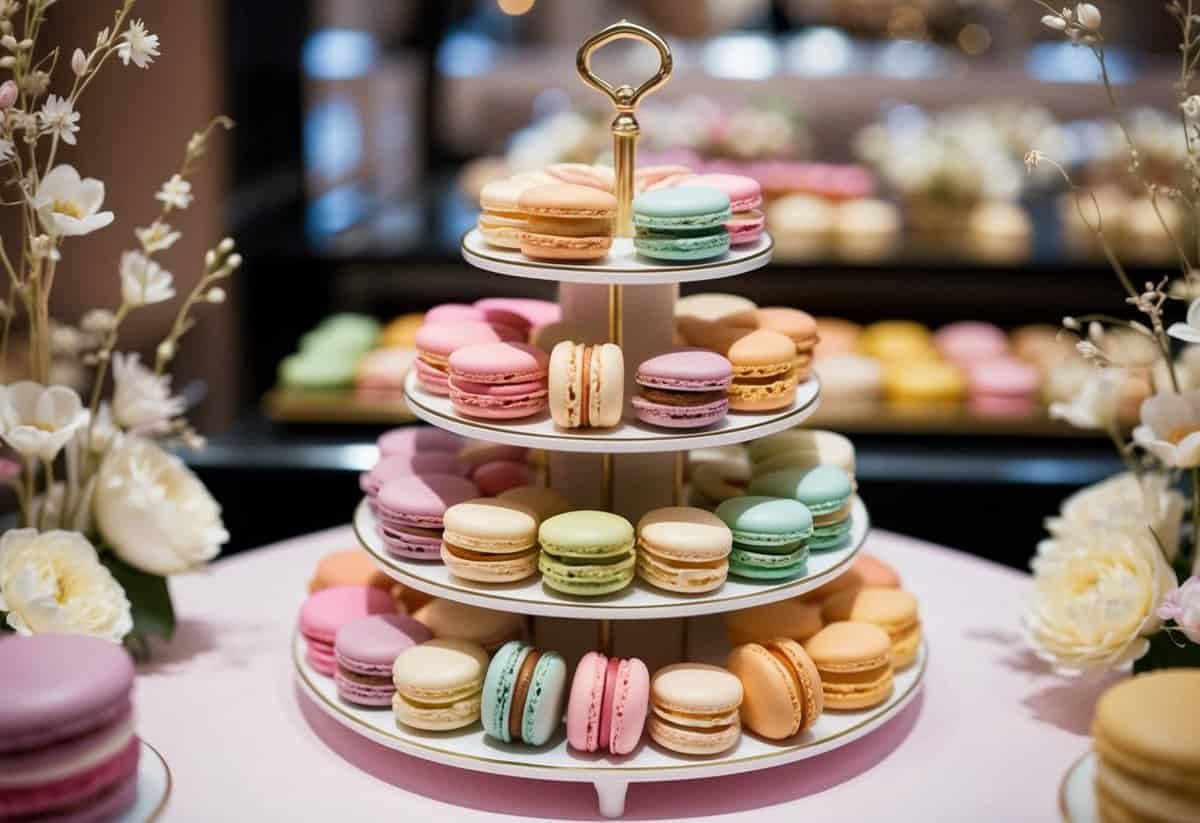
{"left": 715, "top": 495, "right": 812, "bottom": 579}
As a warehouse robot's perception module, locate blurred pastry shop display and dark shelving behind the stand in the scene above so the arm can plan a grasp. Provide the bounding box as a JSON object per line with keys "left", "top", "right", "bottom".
{"left": 21, "top": 0, "right": 1200, "bottom": 567}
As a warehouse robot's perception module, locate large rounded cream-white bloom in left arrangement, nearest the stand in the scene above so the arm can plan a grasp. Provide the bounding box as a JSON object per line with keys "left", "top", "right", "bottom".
{"left": 94, "top": 437, "right": 229, "bottom": 575}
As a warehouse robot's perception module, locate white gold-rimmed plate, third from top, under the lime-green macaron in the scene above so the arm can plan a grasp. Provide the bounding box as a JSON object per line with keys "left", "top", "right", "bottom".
{"left": 354, "top": 497, "right": 870, "bottom": 620}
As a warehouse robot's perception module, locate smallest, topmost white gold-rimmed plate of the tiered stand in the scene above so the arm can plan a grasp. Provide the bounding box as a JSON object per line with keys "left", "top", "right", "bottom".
{"left": 462, "top": 229, "right": 775, "bottom": 286}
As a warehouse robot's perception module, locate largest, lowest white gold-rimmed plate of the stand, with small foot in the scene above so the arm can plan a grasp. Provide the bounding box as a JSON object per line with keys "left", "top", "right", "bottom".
{"left": 293, "top": 632, "right": 928, "bottom": 817}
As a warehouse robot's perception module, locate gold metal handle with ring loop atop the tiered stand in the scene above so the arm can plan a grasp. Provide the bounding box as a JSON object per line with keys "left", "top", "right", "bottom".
{"left": 575, "top": 20, "right": 674, "bottom": 238}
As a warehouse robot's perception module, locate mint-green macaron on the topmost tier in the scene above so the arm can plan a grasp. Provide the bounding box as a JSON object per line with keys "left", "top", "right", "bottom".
{"left": 634, "top": 186, "right": 732, "bottom": 263}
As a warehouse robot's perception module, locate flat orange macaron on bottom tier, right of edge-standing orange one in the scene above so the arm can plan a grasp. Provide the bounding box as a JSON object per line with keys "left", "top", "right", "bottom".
{"left": 804, "top": 620, "right": 894, "bottom": 709}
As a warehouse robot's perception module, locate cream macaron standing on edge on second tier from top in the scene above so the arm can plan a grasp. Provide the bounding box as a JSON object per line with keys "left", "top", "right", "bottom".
{"left": 550, "top": 341, "right": 625, "bottom": 428}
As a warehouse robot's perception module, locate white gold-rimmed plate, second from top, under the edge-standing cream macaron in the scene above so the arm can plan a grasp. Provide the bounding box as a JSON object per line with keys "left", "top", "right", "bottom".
{"left": 404, "top": 371, "right": 821, "bottom": 455}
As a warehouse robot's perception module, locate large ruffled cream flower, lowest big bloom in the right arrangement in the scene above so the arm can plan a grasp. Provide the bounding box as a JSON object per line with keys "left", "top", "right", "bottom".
{"left": 1022, "top": 529, "right": 1175, "bottom": 674}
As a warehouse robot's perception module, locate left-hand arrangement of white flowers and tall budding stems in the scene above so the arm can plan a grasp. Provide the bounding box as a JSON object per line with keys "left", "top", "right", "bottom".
{"left": 0, "top": 0, "right": 241, "bottom": 654}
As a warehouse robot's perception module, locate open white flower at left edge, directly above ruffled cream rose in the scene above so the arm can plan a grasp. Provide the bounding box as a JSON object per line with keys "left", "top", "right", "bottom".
{"left": 0, "top": 380, "right": 89, "bottom": 461}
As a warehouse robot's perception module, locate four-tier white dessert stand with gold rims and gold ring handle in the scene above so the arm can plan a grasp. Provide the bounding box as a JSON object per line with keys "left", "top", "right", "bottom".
{"left": 294, "top": 22, "right": 926, "bottom": 817}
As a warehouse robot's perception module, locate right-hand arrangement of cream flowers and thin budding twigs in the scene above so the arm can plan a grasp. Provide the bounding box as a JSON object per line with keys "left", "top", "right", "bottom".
{"left": 1024, "top": 0, "right": 1200, "bottom": 674}
